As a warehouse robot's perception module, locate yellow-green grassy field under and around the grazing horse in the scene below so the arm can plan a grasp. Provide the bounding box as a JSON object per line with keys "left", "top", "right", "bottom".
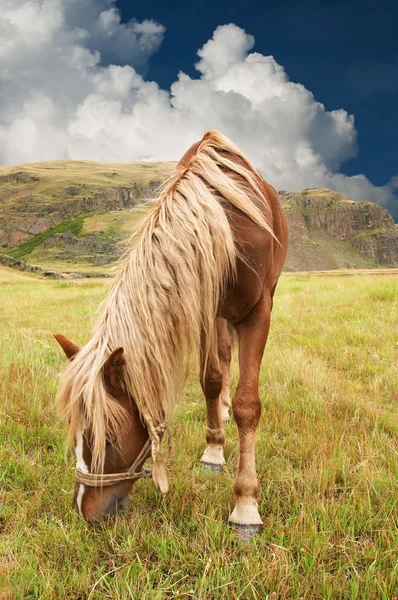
{"left": 0, "top": 269, "right": 398, "bottom": 600}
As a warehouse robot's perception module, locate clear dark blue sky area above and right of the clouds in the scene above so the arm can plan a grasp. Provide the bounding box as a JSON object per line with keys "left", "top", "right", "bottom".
{"left": 117, "top": 0, "right": 398, "bottom": 185}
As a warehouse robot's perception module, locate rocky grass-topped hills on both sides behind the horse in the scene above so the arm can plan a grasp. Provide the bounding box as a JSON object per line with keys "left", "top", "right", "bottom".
{"left": 0, "top": 161, "right": 398, "bottom": 273}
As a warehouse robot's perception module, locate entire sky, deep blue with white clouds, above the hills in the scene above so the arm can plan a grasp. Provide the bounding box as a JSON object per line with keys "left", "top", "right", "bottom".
{"left": 0, "top": 0, "right": 398, "bottom": 219}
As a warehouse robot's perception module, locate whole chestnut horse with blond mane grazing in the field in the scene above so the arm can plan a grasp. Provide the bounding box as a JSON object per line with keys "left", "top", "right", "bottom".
{"left": 55, "top": 130, "right": 288, "bottom": 536}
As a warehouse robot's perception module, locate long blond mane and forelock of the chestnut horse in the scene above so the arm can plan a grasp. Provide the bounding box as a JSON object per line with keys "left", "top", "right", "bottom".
{"left": 57, "top": 131, "right": 273, "bottom": 472}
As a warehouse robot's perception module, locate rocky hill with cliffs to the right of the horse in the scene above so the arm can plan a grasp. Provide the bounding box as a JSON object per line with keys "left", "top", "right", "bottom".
{"left": 280, "top": 188, "right": 398, "bottom": 270}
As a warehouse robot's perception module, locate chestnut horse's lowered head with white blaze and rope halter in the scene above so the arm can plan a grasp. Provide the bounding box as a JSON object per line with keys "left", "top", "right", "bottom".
{"left": 55, "top": 334, "right": 150, "bottom": 523}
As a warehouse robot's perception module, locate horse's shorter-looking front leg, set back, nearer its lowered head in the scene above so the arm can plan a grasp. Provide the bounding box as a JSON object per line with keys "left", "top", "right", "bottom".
{"left": 200, "top": 319, "right": 225, "bottom": 471}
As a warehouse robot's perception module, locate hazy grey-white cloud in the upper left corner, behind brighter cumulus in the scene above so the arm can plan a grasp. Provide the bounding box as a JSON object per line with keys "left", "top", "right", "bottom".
{"left": 0, "top": 0, "right": 164, "bottom": 164}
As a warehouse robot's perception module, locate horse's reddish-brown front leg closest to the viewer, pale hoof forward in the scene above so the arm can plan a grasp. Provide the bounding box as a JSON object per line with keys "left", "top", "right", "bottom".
{"left": 229, "top": 290, "right": 272, "bottom": 539}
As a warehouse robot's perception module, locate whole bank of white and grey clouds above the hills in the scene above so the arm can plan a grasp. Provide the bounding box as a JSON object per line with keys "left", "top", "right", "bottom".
{"left": 0, "top": 6, "right": 397, "bottom": 218}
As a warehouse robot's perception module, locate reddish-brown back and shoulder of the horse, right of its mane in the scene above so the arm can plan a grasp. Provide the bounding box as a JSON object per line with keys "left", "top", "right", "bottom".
{"left": 176, "top": 130, "right": 288, "bottom": 323}
